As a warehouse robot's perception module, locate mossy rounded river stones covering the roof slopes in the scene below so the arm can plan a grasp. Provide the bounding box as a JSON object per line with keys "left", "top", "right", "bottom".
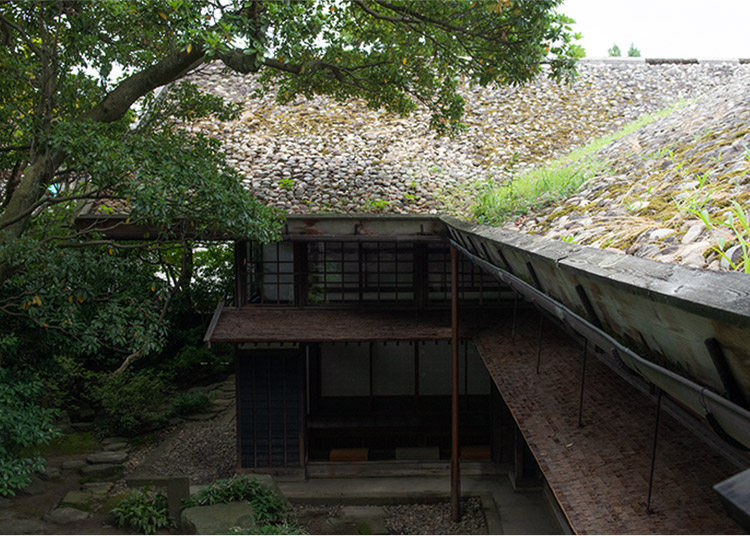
{"left": 182, "top": 60, "right": 750, "bottom": 268}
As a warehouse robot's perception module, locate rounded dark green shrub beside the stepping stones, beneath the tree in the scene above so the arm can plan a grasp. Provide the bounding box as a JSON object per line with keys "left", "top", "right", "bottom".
{"left": 93, "top": 372, "right": 174, "bottom": 436}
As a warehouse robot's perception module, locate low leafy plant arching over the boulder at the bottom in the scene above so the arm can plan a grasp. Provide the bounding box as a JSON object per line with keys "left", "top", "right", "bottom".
{"left": 185, "top": 475, "right": 287, "bottom": 525}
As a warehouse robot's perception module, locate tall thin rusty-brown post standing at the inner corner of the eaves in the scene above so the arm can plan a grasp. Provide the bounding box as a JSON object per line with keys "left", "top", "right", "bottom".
{"left": 451, "top": 245, "right": 461, "bottom": 523}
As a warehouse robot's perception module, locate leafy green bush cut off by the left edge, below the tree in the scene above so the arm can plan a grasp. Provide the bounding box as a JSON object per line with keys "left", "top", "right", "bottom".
{"left": 0, "top": 369, "right": 59, "bottom": 496}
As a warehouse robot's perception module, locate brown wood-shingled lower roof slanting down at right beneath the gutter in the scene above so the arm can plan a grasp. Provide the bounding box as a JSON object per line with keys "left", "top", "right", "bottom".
{"left": 475, "top": 312, "right": 741, "bottom": 534}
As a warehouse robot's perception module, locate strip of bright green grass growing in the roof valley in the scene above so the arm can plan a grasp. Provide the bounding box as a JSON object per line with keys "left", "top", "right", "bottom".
{"left": 471, "top": 101, "right": 688, "bottom": 225}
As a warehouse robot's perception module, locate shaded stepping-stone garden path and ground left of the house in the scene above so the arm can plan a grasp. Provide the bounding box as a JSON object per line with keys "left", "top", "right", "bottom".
{"left": 0, "top": 375, "right": 234, "bottom": 534}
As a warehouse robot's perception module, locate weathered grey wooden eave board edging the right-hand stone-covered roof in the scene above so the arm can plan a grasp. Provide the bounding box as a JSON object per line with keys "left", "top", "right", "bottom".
{"left": 443, "top": 218, "right": 750, "bottom": 400}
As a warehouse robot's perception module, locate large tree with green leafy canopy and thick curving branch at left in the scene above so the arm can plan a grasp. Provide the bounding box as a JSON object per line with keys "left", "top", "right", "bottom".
{"left": 0, "top": 0, "right": 576, "bottom": 368}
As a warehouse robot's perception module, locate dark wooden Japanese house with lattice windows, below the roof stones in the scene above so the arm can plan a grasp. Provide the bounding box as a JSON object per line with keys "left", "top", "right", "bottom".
{"left": 79, "top": 208, "right": 750, "bottom": 533}
